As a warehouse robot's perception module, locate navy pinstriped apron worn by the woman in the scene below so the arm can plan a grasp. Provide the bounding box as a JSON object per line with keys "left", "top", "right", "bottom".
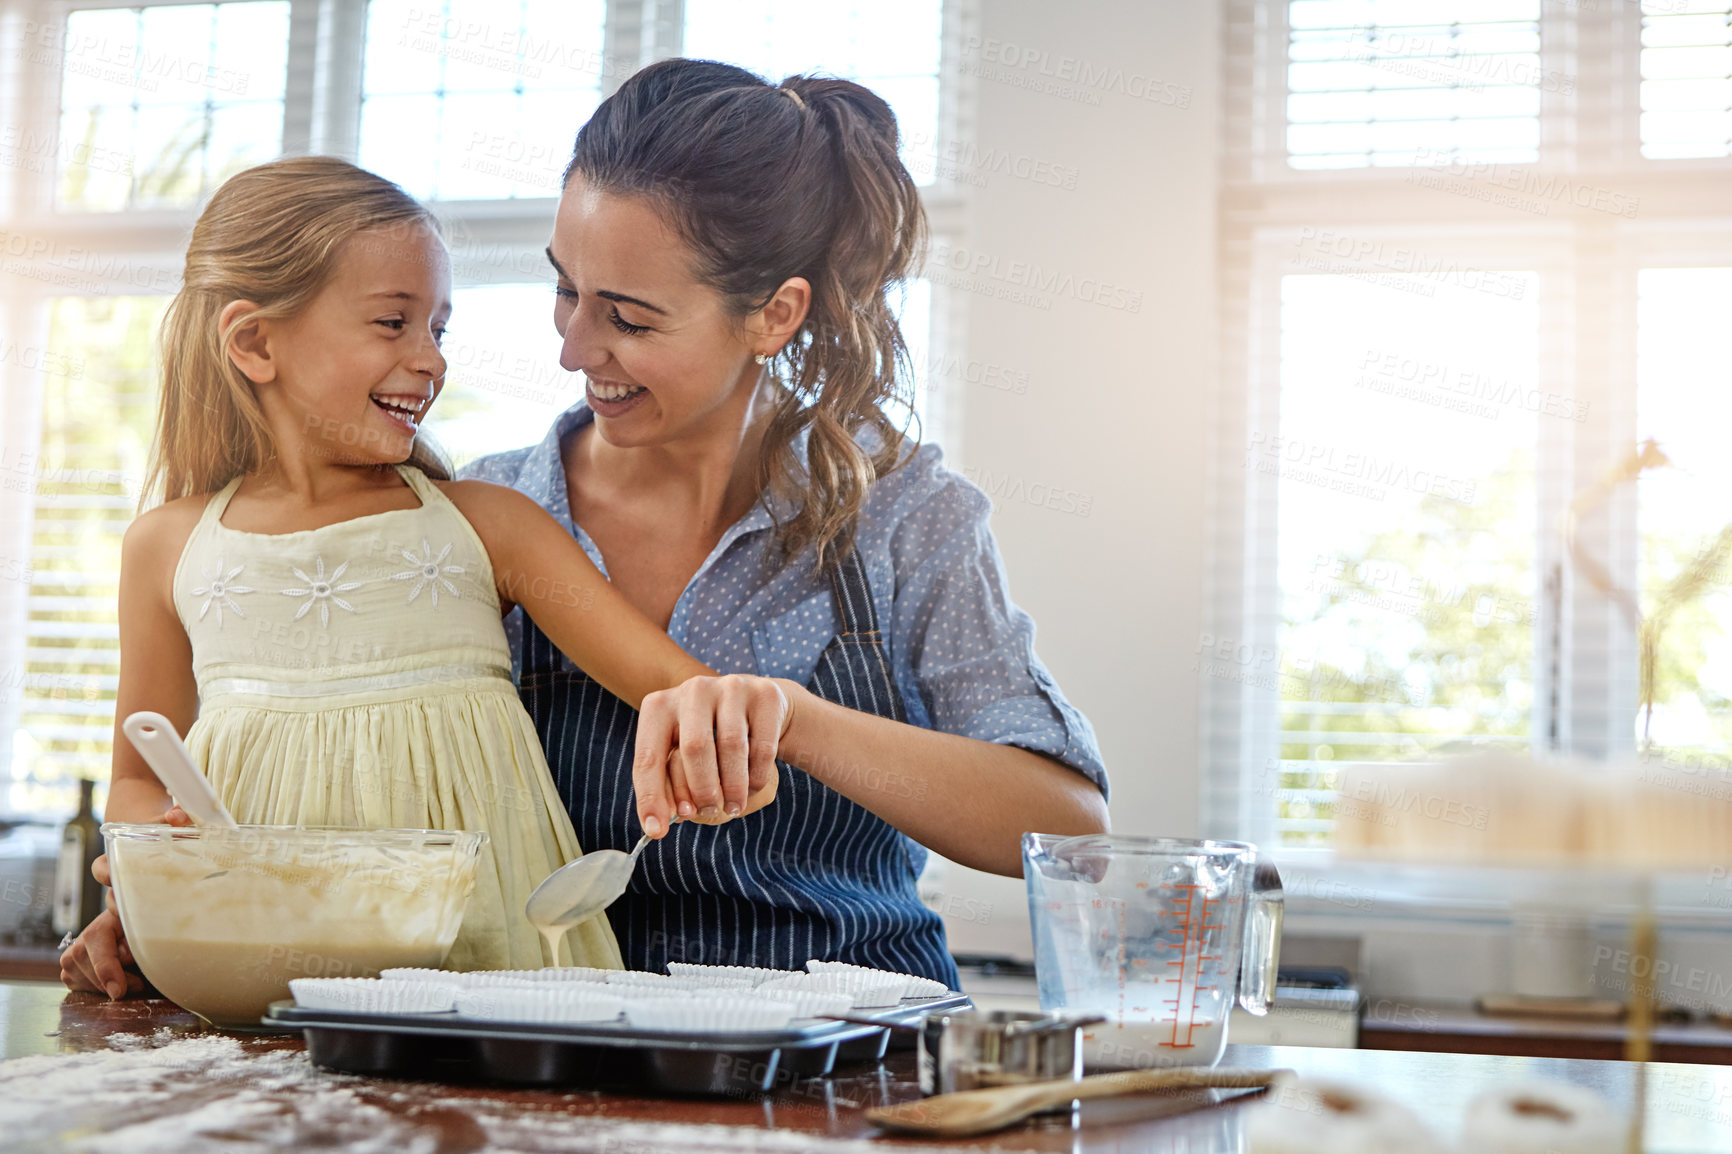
{"left": 520, "top": 551, "right": 958, "bottom": 989}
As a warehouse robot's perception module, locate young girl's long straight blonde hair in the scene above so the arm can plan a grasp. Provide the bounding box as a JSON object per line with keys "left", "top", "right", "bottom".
{"left": 139, "top": 156, "right": 450, "bottom": 509}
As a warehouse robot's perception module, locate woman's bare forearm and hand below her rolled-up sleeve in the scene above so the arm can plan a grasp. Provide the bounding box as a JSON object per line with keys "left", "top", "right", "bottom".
{"left": 634, "top": 677, "right": 1108, "bottom": 877}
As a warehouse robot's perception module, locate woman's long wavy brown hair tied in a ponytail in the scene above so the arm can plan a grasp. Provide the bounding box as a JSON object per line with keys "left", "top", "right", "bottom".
{"left": 565, "top": 59, "right": 927, "bottom": 567}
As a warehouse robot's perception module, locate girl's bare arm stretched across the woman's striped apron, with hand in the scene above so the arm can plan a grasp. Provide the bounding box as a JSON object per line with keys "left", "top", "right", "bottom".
{"left": 440, "top": 480, "right": 786, "bottom": 817}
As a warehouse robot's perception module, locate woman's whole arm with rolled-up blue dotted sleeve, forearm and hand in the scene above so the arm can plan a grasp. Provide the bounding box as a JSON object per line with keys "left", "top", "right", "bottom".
{"left": 634, "top": 447, "right": 1107, "bottom": 875}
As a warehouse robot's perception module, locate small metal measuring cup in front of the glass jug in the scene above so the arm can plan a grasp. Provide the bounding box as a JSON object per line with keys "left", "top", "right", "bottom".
{"left": 920, "top": 1010, "right": 1107, "bottom": 1095}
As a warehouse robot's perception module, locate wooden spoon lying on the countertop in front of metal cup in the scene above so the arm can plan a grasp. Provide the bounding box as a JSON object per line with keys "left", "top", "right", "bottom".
{"left": 866, "top": 1066, "right": 1292, "bottom": 1137}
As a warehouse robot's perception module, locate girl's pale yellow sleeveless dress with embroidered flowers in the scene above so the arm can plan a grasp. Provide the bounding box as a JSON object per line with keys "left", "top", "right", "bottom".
{"left": 175, "top": 466, "right": 620, "bottom": 970}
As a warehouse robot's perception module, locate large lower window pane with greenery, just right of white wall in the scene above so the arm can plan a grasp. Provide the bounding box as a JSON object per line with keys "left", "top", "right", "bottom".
{"left": 1267, "top": 272, "right": 1540, "bottom": 846}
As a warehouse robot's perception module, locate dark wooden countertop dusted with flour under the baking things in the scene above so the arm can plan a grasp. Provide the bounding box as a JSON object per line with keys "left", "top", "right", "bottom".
{"left": 10, "top": 982, "right": 1732, "bottom": 1154}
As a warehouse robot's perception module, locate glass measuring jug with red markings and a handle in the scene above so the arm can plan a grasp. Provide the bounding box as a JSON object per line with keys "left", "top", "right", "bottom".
{"left": 1022, "top": 833, "right": 1282, "bottom": 1073}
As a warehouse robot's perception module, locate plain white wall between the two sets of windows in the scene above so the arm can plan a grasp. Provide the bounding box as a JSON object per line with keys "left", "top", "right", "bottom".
{"left": 928, "top": 0, "right": 1221, "bottom": 953}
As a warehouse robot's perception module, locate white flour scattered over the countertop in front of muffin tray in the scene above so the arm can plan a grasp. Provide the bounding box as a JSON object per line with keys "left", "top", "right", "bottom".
{"left": 0, "top": 1029, "right": 944, "bottom": 1154}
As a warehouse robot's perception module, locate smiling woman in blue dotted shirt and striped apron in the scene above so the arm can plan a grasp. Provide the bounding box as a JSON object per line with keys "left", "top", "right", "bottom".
{"left": 464, "top": 59, "right": 1107, "bottom": 986}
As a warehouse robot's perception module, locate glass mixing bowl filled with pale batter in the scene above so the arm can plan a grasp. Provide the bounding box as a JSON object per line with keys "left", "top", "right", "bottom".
{"left": 102, "top": 821, "right": 487, "bottom": 1026}
